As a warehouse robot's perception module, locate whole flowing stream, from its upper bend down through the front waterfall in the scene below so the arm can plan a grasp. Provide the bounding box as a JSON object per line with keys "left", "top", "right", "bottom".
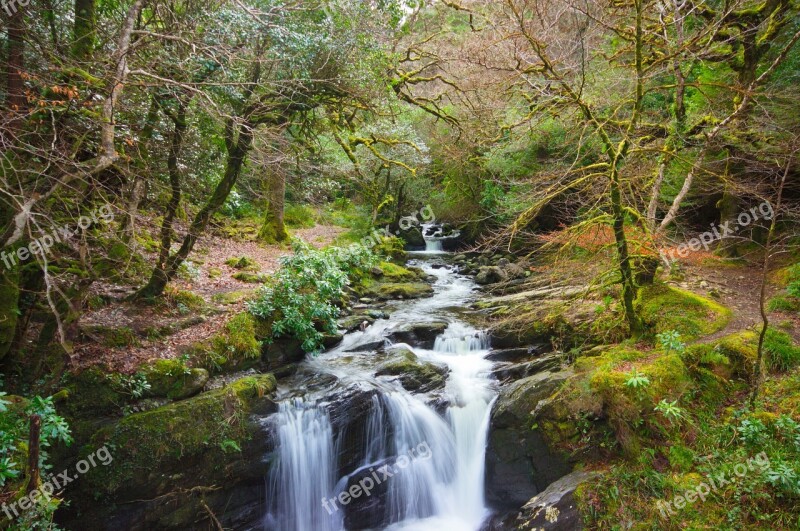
{"left": 264, "top": 242, "right": 497, "bottom": 531}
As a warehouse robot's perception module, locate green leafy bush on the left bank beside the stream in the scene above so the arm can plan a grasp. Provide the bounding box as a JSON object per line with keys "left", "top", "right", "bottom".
{"left": 247, "top": 241, "right": 379, "bottom": 352}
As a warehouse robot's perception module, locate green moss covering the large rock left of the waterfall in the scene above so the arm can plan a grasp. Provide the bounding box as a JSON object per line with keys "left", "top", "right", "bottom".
{"left": 86, "top": 374, "right": 277, "bottom": 495}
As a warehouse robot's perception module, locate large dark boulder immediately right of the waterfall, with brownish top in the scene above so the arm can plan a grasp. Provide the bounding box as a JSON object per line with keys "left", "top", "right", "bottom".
{"left": 486, "top": 370, "right": 573, "bottom": 510}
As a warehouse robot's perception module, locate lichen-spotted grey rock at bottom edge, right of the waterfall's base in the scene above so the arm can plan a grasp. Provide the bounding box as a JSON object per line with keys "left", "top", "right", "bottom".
{"left": 515, "top": 471, "right": 598, "bottom": 531}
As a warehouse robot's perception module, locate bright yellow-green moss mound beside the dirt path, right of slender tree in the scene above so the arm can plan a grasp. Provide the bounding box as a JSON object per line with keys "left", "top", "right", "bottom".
{"left": 636, "top": 285, "right": 732, "bottom": 340}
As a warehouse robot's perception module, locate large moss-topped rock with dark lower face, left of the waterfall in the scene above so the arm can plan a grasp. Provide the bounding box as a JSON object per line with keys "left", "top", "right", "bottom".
{"left": 60, "top": 374, "right": 277, "bottom": 530}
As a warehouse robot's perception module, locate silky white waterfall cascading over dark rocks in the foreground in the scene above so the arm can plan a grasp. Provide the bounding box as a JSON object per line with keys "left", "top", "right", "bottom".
{"left": 265, "top": 260, "right": 496, "bottom": 531}
